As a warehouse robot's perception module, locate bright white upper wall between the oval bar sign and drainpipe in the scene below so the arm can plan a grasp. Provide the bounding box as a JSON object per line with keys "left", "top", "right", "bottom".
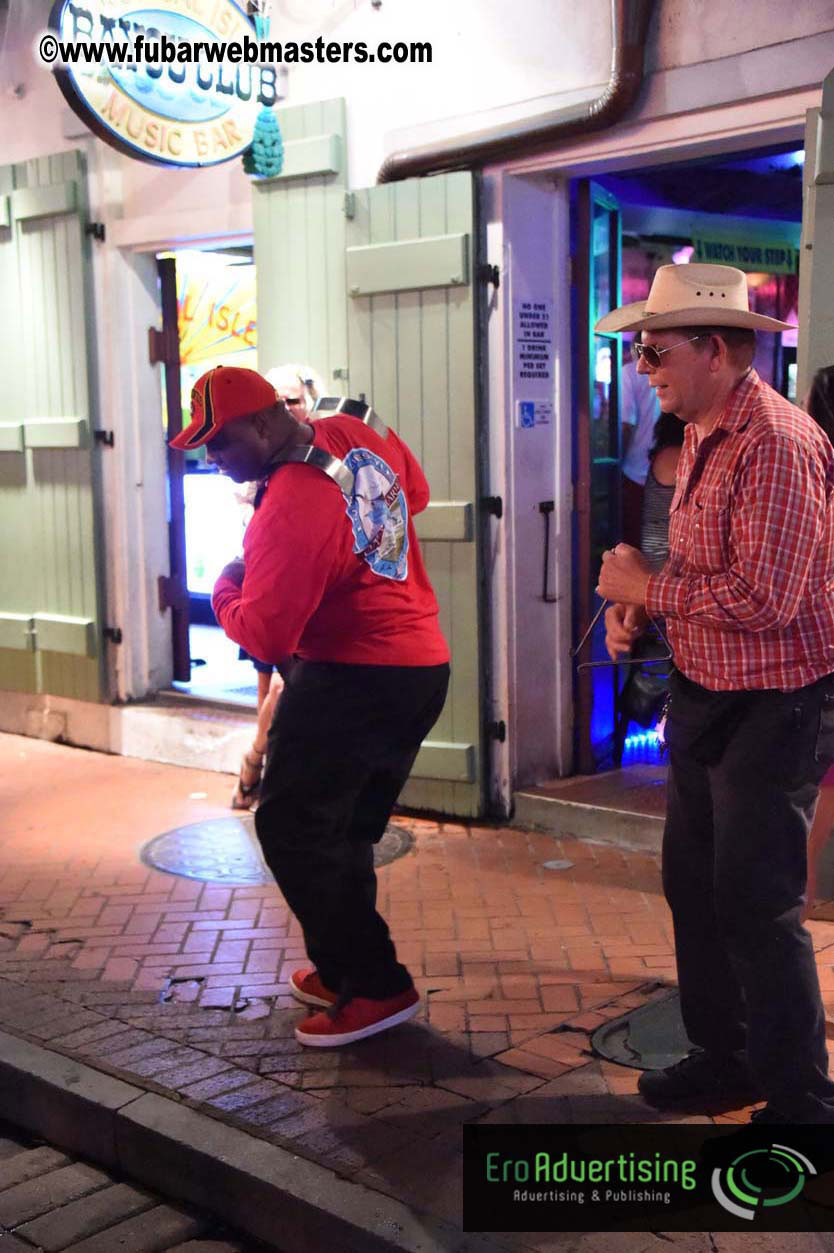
{"left": 273, "top": 0, "right": 611, "bottom": 187}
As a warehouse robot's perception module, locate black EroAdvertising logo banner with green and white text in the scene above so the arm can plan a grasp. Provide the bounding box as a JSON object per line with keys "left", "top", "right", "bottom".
{"left": 463, "top": 1123, "right": 834, "bottom": 1232}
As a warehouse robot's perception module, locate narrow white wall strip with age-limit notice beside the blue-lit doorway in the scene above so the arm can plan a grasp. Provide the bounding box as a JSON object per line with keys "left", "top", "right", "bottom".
{"left": 486, "top": 177, "right": 572, "bottom": 786}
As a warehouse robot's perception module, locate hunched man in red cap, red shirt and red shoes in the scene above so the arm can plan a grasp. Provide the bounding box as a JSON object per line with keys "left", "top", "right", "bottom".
{"left": 172, "top": 366, "right": 450, "bottom": 1048}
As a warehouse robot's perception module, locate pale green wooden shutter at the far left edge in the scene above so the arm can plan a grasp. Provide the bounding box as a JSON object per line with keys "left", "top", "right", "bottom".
{"left": 0, "top": 153, "right": 104, "bottom": 700}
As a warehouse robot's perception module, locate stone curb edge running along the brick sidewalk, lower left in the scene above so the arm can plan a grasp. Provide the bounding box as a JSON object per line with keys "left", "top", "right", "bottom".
{"left": 0, "top": 1031, "right": 508, "bottom": 1253}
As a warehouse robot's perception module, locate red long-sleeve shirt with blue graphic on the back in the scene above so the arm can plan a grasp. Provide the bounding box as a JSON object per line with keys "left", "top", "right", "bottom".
{"left": 212, "top": 415, "right": 448, "bottom": 665}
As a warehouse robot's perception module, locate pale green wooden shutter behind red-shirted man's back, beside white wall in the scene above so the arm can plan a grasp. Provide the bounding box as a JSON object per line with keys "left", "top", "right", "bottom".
{"left": 347, "top": 172, "right": 483, "bottom": 816}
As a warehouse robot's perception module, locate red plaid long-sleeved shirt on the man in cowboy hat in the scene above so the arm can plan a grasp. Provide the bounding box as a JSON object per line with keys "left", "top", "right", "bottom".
{"left": 646, "top": 370, "right": 834, "bottom": 692}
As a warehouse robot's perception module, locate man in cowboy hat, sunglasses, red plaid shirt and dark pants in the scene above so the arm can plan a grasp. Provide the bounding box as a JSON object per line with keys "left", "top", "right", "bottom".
{"left": 597, "top": 264, "right": 834, "bottom": 1123}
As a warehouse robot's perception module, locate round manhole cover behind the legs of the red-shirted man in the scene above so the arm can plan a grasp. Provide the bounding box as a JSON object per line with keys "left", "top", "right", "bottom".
{"left": 142, "top": 814, "right": 414, "bottom": 887}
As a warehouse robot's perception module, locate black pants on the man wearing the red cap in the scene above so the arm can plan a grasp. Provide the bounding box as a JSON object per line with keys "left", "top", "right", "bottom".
{"left": 255, "top": 662, "right": 450, "bottom": 1000}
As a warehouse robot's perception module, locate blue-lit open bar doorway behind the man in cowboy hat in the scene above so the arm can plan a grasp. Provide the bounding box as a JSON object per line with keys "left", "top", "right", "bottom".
{"left": 571, "top": 144, "right": 804, "bottom": 774}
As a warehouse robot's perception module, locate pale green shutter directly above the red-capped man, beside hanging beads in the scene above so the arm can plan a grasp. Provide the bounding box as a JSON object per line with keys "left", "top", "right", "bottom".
{"left": 253, "top": 100, "right": 347, "bottom": 385}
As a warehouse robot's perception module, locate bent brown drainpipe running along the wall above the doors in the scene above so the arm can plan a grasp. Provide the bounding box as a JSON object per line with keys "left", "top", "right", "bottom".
{"left": 377, "top": 0, "right": 655, "bottom": 183}
